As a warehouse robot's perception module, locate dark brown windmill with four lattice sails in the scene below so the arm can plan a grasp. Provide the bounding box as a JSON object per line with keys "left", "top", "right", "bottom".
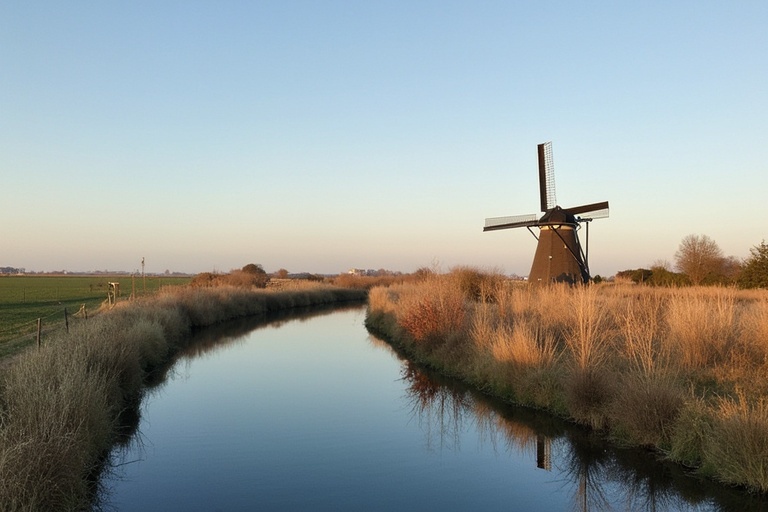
{"left": 483, "top": 142, "right": 608, "bottom": 284}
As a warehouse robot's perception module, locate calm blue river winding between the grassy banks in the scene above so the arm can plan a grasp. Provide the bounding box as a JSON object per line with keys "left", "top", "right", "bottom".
{"left": 99, "top": 307, "right": 763, "bottom": 512}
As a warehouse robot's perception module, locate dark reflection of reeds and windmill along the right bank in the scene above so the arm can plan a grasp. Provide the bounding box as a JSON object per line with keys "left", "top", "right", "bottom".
{"left": 392, "top": 360, "right": 768, "bottom": 512}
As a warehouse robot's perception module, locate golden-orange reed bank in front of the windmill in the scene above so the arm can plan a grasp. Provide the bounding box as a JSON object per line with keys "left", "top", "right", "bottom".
{"left": 366, "top": 269, "right": 768, "bottom": 493}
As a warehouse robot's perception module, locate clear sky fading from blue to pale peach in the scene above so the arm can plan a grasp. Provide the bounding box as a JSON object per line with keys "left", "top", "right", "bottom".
{"left": 0, "top": 0, "right": 768, "bottom": 276}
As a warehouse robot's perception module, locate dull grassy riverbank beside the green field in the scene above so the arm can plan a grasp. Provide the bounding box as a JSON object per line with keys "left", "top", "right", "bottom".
{"left": 0, "top": 287, "right": 365, "bottom": 511}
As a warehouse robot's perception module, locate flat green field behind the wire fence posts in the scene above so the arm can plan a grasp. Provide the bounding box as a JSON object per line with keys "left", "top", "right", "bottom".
{"left": 0, "top": 275, "right": 191, "bottom": 357}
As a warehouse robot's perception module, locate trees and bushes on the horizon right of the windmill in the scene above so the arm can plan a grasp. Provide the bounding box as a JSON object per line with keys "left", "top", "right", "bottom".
{"left": 616, "top": 235, "right": 768, "bottom": 288}
